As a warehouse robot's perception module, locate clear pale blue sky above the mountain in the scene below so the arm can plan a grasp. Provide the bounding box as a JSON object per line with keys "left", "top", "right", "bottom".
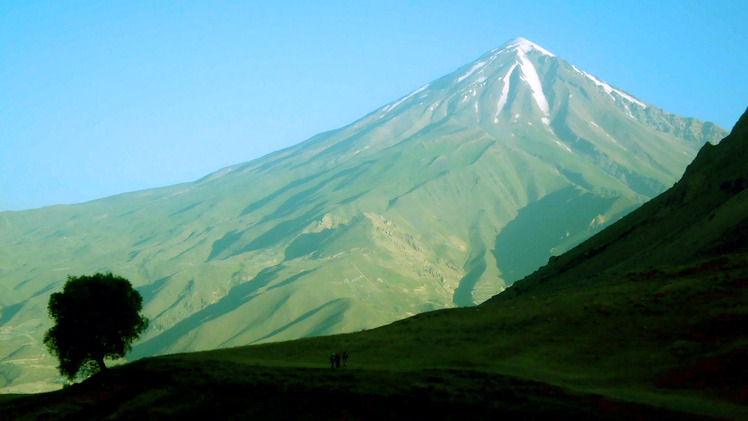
{"left": 0, "top": 0, "right": 748, "bottom": 210}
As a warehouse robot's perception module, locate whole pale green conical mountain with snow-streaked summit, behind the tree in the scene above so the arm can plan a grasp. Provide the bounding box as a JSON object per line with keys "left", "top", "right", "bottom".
{"left": 0, "top": 39, "right": 726, "bottom": 390}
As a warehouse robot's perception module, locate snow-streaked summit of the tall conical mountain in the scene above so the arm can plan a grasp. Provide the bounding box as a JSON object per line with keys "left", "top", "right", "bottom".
{"left": 377, "top": 38, "right": 660, "bottom": 128}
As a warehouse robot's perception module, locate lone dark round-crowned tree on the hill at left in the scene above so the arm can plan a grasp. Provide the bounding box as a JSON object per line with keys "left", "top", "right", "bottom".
{"left": 44, "top": 273, "right": 148, "bottom": 380}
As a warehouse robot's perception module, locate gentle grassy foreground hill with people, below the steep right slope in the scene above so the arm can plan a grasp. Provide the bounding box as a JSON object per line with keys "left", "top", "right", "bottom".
{"left": 0, "top": 254, "right": 748, "bottom": 420}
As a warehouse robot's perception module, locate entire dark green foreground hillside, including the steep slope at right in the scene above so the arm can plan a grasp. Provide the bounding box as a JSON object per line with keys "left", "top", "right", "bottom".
{"left": 0, "top": 112, "right": 748, "bottom": 419}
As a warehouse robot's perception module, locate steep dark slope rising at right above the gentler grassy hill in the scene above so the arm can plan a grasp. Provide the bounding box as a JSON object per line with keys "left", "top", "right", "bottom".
{"left": 490, "top": 106, "right": 748, "bottom": 302}
